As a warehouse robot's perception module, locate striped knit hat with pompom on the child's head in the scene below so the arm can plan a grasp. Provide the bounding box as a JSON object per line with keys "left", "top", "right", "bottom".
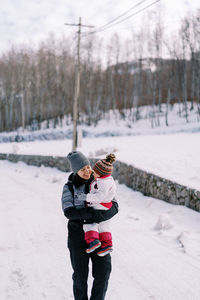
{"left": 93, "top": 153, "right": 116, "bottom": 177}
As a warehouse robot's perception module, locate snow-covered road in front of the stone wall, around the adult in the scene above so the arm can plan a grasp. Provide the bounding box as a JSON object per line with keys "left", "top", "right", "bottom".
{"left": 0, "top": 163, "right": 200, "bottom": 300}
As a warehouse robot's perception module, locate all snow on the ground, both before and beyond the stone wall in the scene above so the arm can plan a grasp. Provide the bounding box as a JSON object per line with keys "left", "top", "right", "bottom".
{"left": 0, "top": 101, "right": 200, "bottom": 300}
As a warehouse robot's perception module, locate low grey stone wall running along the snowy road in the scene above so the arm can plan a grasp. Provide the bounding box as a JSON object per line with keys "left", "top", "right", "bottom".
{"left": 0, "top": 153, "right": 200, "bottom": 211}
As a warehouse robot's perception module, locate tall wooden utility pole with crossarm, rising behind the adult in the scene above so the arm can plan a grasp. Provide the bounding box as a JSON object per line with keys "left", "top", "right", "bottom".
{"left": 65, "top": 17, "right": 94, "bottom": 151}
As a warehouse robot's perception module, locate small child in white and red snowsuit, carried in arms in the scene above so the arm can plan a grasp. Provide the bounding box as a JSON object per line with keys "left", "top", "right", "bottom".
{"left": 83, "top": 154, "right": 116, "bottom": 256}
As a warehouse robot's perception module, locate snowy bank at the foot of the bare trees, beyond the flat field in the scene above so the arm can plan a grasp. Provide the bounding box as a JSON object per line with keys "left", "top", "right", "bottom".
{"left": 0, "top": 103, "right": 200, "bottom": 143}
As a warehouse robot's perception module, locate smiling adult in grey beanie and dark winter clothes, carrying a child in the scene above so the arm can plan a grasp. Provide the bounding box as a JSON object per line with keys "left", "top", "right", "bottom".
{"left": 62, "top": 151, "right": 118, "bottom": 300}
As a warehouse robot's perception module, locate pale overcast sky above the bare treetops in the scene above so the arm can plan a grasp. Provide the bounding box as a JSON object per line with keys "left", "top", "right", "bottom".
{"left": 0, "top": 0, "right": 200, "bottom": 52}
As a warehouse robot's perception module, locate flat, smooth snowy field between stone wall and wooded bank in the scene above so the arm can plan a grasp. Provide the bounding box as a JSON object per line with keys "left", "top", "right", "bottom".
{"left": 0, "top": 133, "right": 200, "bottom": 190}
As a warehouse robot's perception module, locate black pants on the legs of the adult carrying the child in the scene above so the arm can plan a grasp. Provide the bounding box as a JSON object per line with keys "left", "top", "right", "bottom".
{"left": 69, "top": 247, "right": 111, "bottom": 300}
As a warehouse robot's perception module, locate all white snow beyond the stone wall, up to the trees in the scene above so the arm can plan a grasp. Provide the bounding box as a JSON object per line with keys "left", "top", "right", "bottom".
{"left": 0, "top": 103, "right": 200, "bottom": 190}
